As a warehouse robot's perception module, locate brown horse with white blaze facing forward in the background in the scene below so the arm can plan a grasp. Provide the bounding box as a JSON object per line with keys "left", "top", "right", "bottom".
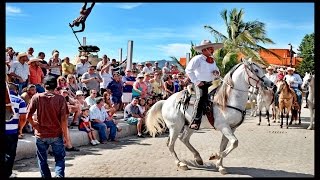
{"left": 277, "top": 80, "right": 297, "bottom": 129}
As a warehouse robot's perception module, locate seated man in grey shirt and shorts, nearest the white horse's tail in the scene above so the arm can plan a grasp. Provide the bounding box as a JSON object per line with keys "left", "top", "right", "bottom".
{"left": 124, "top": 97, "right": 145, "bottom": 138}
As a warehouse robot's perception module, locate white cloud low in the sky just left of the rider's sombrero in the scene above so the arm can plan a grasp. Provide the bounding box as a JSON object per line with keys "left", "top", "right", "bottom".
{"left": 157, "top": 43, "right": 191, "bottom": 59}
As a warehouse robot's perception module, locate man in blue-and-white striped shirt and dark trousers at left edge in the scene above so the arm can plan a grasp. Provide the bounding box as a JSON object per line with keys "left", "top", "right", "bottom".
{"left": 1, "top": 83, "right": 27, "bottom": 178}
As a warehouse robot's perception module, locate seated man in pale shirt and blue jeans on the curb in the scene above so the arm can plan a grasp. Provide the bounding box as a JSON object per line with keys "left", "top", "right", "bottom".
{"left": 89, "top": 97, "right": 117, "bottom": 144}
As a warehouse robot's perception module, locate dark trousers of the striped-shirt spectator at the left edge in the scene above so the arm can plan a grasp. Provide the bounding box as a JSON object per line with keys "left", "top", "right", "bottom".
{"left": 3, "top": 134, "right": 18, "bottom": 177}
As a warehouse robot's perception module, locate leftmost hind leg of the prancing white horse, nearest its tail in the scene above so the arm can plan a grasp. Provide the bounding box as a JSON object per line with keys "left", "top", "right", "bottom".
{"left": 167, "top": 127, "right": 189, "bottom": 170}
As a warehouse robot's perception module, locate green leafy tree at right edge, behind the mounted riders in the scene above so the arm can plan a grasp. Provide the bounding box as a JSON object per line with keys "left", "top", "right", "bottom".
{"left": 297, "top": 33, "right": 315, "bottom": 76}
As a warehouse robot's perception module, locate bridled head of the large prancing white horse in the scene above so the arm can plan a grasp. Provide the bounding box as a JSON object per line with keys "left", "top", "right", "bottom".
{"left": 243, "top": 59, "right": 274, "bottom": 88}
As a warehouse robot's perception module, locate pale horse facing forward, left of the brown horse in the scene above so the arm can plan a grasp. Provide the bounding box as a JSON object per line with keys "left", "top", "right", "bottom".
{"left": 257, "top": 87, "right": 276, "bottom": 126}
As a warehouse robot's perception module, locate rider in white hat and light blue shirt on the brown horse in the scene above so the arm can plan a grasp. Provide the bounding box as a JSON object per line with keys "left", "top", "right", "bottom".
{"left": 284, "top": 67, "right": 302, "bottom": 104}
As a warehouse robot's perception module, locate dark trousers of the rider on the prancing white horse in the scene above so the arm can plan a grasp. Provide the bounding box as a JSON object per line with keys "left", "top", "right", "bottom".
{"left": 195, "top": 82, "right": 212, "bottom": 121}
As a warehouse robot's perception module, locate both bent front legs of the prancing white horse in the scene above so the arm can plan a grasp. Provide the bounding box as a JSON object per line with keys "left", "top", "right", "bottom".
{"left": 210, "top": 126, "right": 238, "bottom": 174}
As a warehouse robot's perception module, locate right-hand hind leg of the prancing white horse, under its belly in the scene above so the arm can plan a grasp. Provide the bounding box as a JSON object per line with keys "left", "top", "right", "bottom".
{"left": 180, "top": 127, "right": 203, "bottom": 165}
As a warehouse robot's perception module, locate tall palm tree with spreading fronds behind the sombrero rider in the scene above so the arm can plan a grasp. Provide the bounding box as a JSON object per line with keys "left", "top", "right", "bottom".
{"left": 204, "top": 8, "right": 281, "bottom": 67}
